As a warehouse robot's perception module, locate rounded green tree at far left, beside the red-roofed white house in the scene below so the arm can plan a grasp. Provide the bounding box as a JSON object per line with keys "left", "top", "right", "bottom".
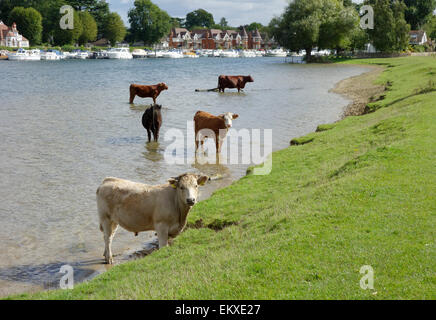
{"left": 9, "top": 7, "right": 42, "bottom": 44}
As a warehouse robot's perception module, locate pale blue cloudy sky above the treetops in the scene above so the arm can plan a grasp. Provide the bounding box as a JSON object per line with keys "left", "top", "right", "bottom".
{"left": 106, "top": 0, "right": 362, "bottom": 27}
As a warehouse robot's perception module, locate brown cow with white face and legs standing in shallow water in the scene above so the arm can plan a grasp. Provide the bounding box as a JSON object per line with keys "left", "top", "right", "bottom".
{"left": 194, "top": 111, "right": 239, "bottom": 154}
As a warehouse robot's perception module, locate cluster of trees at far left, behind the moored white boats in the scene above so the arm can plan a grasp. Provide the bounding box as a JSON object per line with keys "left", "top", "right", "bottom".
{"left": 0, "top": 0, "right": 127, "bottom": 45}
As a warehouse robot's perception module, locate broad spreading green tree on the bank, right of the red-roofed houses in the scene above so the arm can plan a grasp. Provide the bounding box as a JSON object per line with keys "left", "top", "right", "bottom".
{"left": 269, "top": 0, "right": 358, "bottom": 61}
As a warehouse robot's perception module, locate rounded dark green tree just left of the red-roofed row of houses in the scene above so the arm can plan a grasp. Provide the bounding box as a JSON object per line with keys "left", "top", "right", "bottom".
{"left": 128, "top": 0, "right": 171, "bottom": 45}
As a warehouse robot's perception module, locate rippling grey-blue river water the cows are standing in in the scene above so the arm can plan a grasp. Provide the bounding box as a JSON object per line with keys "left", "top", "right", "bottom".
{"left": 0, "top": 58, "right": 366, "bottom": 296}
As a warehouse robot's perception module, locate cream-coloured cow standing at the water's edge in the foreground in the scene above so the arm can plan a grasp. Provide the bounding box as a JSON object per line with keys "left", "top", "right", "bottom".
{"left": 97, "top": 173, "right": 209, "bottom": 264}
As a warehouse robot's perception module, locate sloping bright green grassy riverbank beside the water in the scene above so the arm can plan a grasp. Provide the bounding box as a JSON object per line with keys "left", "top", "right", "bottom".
{"left": 8, "top": 57, "right": 436, "bottom": 299}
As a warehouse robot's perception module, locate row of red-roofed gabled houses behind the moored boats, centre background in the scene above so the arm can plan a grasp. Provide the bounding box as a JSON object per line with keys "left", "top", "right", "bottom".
{"left": 167, "top": 27, "right": 277, "bottom": 50}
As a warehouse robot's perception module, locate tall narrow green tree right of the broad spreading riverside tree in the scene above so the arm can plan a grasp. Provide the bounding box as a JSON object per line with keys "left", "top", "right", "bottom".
{"left": 365, "top": 0, "right": 410, "bottom": 52}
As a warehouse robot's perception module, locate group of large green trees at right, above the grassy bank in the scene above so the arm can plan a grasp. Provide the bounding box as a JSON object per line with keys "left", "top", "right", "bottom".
{"left": 269, "top": 0, "right": 436, "bottom": 60}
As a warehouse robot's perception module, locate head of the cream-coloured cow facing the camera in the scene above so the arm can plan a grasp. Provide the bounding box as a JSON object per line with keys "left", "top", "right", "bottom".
{"left": 168, "top": 173, "right": 209, "bottom": 207}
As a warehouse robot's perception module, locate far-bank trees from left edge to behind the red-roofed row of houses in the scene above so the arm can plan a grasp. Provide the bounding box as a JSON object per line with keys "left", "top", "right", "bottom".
{"left": 0, "top": 0, "right": 268, "bottom": 45}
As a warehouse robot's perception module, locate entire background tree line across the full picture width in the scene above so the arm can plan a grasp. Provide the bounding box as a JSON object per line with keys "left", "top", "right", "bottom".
{"left": 0, "top": 0, "right": 436, "bottom": 52}
